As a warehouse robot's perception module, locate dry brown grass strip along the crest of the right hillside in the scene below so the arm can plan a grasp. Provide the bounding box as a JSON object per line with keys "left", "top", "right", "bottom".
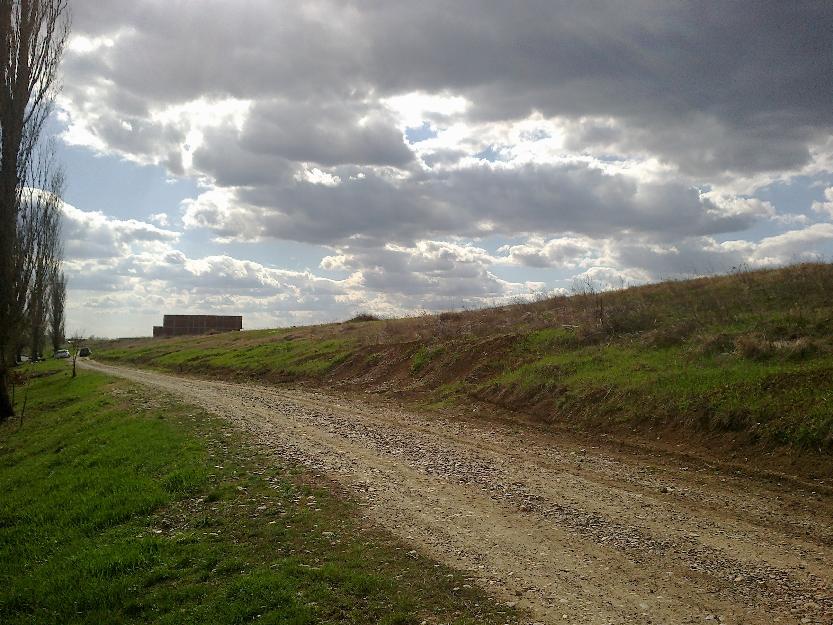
{"left": 324, "top": 263, "right": 833, "bottom": 346}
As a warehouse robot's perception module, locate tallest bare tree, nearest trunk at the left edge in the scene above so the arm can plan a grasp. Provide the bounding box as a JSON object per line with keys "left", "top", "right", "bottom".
{"left": 0, "top": 0, "right": 69, "bottom": 421}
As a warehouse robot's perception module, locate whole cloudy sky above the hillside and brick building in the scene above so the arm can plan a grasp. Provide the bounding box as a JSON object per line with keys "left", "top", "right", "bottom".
{"left": 49, "top": 0, "right": 833, "bottom": 337}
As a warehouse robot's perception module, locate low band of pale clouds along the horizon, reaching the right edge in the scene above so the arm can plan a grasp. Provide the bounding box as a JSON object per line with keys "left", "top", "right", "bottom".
{"left": 65, "top": 195, "right": 833, "bottom": 333}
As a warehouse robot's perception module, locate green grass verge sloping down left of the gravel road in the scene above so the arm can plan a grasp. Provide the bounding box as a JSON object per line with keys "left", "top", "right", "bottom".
{"left": 0, "top": 363, "right": 517, "bottom": 625}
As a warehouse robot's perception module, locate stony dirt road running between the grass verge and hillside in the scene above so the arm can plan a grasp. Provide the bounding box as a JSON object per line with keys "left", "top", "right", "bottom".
{"left": 84, "top": 362, "right": 833, "bottom": 625}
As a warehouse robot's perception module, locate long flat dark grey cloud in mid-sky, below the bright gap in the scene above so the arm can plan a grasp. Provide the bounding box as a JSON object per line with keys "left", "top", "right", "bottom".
{"left": 186, "top": 164, "right": 765, "bottom": 244}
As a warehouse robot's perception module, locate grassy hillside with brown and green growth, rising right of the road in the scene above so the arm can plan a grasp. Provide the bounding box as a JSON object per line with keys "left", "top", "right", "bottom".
{"left": 96, "top": 263, "right": 833, "bottom": 454}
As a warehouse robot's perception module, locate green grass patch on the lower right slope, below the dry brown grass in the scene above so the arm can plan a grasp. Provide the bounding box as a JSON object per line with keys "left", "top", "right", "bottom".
{"left": 479, "top": 339, "right": 833, "bottom": 446}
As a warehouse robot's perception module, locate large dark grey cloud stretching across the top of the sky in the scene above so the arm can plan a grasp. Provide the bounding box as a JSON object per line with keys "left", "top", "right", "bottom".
{"left": 68, "top": 0, "right": 833, "bottom": 176}
